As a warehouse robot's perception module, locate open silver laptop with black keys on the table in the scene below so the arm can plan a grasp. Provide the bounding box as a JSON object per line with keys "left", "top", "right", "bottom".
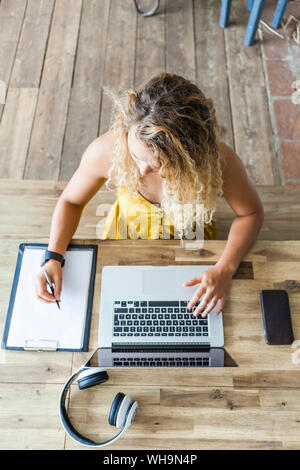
{"left": 98, "top": 265, "right": 236, "bottom": 367}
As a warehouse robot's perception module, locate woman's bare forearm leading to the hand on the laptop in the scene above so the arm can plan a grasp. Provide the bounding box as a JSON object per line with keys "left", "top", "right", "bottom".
{"left": 217, "top": 210, "right": 264, "bottom": 275}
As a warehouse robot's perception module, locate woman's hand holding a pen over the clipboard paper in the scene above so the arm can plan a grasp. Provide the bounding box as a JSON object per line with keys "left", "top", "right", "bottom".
{"left": 34, "top": 259, "right": 62, "bottom": 303}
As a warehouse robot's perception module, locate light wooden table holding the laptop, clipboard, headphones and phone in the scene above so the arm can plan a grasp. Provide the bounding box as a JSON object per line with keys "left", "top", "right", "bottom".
{"left": 0, "top": 238, "right": 300, "bottom": 450}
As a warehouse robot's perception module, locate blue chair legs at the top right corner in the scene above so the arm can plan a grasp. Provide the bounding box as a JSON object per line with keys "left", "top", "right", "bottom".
{"left": 220, "top": 0, "right": 289, "bottom": 46}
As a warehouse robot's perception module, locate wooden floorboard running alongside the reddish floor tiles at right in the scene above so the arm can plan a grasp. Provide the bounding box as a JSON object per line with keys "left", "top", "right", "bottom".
{"left": 224, "top": 2, "right": 280, "bottom": 184}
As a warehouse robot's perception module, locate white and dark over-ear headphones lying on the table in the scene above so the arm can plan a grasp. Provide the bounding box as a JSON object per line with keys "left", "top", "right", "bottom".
{"left": 59, "top": 356, "right": 138, "bottom": 447}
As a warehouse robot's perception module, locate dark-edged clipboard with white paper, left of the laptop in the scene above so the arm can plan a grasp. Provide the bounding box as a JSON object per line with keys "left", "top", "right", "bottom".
{"left": 1, "top": 243, "right": 98, "bottom": 352}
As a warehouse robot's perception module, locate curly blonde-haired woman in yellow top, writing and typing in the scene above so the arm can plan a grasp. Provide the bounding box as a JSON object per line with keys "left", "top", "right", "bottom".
{"left": 35, "top": 73, "right": 263, "bottom": 317}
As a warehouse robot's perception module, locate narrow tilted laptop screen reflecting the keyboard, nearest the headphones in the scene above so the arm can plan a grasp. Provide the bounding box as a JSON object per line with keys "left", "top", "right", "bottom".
{"left": 87, "top": 346, "right": 238, "bottom": 368}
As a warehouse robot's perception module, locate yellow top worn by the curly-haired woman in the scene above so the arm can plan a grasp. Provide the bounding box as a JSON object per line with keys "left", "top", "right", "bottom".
{"left": 102, "top": 185, "right": 218, "bottom": 240}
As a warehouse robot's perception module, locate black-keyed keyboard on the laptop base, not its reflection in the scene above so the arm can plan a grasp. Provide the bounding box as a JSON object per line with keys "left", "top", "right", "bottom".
{"left": 113, "top": 300, "right": 209, "bottom": 337}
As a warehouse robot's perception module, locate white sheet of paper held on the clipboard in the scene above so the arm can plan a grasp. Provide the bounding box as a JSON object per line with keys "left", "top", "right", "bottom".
{"left": 6, "top": 246, "right": 93, "bottom": 350}
